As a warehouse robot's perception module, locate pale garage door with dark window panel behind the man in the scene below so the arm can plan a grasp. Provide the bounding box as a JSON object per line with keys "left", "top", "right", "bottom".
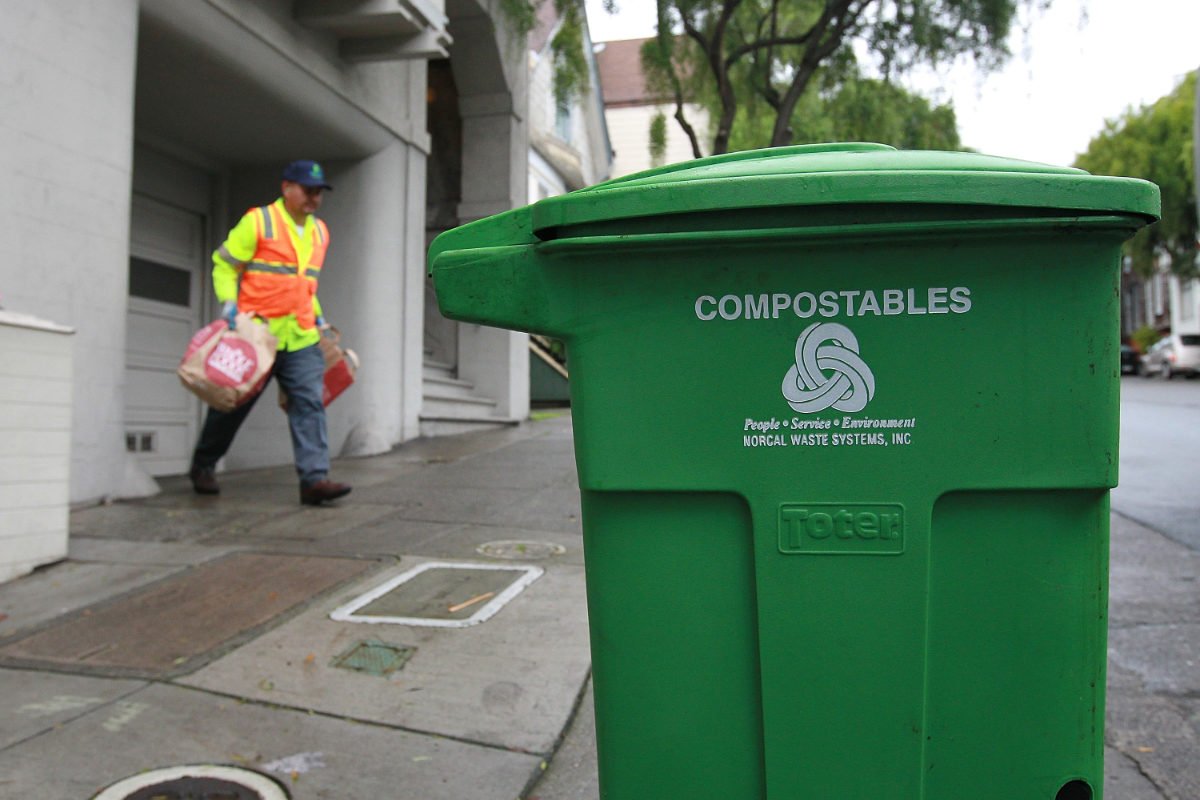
{"left": 125, "top": 193, "right": 208, "bottom": 475}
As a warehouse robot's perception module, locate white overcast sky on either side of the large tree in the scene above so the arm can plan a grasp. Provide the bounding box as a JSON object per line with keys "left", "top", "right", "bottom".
{"left": 587, "top": 0, "right": 1200, "bottom": 164}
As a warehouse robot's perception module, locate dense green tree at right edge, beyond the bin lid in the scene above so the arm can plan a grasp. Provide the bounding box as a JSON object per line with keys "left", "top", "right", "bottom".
{"left": 1075, "top": 72, "right": 1198, "bottom": 276}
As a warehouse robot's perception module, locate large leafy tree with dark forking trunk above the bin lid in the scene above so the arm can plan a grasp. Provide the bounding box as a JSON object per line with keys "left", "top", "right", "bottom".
{"left": 643, "top": 0, "right": 1050, "bottom": 156}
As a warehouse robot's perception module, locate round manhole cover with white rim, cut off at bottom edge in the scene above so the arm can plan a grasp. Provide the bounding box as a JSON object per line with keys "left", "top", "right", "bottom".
{"left": 92, "top": 764, "right": 288, "bottom": 800}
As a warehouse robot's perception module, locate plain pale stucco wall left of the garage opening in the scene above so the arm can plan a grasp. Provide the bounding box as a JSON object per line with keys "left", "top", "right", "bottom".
{"left": 0, "top": 0, "right": 138, "bottom": 500}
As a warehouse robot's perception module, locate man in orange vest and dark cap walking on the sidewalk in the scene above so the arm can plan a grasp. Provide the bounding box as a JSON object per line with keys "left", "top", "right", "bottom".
{"left": 188, "top": 161, "right": 350, "bottom": 505}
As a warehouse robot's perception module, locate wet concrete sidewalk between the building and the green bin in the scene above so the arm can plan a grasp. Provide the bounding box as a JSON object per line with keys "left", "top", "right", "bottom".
{"left": 0, "top": 415, "right": 590, "bottom": 800}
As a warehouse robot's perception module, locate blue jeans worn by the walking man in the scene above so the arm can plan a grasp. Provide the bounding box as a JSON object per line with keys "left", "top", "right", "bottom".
{"left": 192, "top": 344, "right": 329, "bottom": 487}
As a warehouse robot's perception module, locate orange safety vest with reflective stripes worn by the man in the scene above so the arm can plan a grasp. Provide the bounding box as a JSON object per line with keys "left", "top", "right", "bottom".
{"left": 238, "top": 203, "right": 329, "bottom": 329}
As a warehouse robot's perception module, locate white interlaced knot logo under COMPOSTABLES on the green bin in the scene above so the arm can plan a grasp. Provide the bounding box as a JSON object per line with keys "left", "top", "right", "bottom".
{"left": 784, "top": 323, "right": 875, "bottom": 414}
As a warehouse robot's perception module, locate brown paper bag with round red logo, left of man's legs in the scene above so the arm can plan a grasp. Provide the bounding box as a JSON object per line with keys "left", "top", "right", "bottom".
{"left": 175, "top": 314, "right": 277, "bottom": 411}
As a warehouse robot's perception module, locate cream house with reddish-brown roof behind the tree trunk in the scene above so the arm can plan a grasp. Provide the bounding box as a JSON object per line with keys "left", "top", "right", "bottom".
{"left": 595, "top": 38, "right": 708, "bottom": 178}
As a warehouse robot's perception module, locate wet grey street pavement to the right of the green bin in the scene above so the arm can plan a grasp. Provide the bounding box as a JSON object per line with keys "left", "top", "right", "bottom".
{"left": 1105, "top": 378, "right": 1200, "bottom": 800}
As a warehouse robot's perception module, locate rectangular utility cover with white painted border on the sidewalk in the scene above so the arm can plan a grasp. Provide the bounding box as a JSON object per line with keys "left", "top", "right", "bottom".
{"left": 329, "top": 561, "right": 544, "bottom": 627}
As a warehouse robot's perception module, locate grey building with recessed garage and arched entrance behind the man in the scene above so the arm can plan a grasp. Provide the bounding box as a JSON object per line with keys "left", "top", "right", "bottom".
{"left": 0, "top": 0, "right": 529, "bottom": 582}
